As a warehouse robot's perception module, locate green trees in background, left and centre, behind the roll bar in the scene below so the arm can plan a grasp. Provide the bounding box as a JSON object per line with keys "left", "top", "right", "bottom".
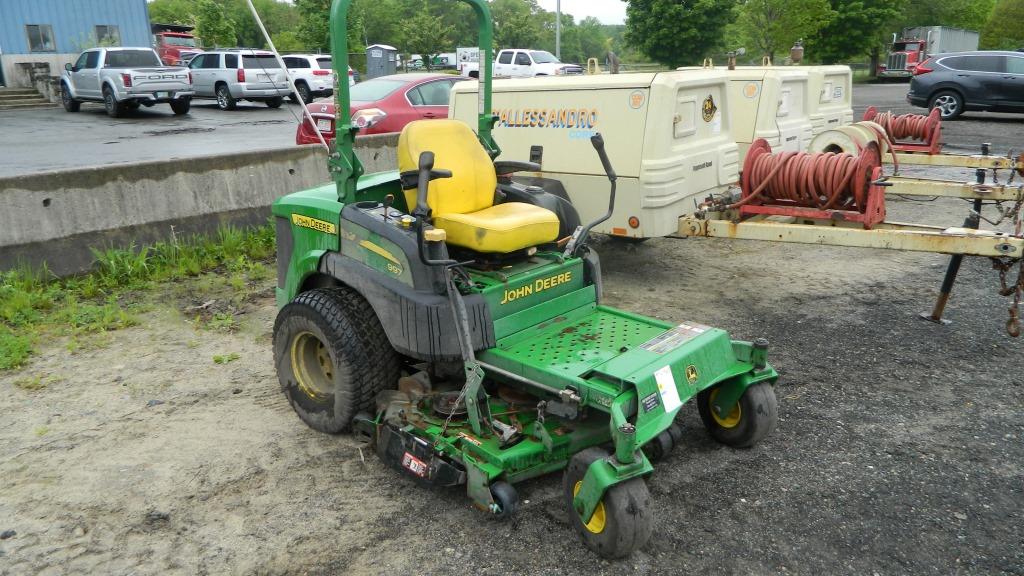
{"left": 150, "top": 0, "right": 645, "bottom": 64}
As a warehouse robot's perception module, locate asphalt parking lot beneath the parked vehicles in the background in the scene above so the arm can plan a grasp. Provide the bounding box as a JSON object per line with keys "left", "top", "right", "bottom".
{"left": 0, "top": 83, "right": 1024, "bottom": 177}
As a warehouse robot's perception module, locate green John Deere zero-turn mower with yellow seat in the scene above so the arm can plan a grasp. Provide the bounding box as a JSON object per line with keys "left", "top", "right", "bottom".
{"left": 273, "top": 0, "right": 778, "bottom": 558}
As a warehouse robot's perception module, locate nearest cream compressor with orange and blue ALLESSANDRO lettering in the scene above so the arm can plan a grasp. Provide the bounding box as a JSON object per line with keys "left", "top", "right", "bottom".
{"left": 449, "top": 70, "right": 739, "bottom": 238}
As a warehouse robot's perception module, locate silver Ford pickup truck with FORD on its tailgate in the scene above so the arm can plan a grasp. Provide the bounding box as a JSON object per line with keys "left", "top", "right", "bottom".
{"left": 60, "top": 48, "right": 195, "bottom": 118}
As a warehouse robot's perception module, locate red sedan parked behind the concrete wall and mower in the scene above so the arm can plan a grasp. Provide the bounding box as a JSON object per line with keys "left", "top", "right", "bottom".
{"left": 295, "top": 74, "right": 465, "bottom": 145}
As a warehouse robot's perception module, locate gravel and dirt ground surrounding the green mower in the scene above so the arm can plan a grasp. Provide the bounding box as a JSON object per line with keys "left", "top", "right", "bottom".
{"left": 0, "top": 83, "right": 1024, "bottom": 575}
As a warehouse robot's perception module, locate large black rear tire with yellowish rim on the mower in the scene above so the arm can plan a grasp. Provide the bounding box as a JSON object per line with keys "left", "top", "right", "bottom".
{"left": 273, "top": 288, "right": 400, "bottom": 434}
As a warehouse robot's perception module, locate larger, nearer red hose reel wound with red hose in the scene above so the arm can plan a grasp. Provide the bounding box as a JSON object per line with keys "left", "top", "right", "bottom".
{"left": 730, "top": 138, "right": 886, "bottom": 230}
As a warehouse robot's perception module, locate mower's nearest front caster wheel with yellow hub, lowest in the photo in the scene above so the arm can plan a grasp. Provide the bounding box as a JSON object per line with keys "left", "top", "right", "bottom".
{"left": 562, "top": 448, "right": 654, "bottom": 559}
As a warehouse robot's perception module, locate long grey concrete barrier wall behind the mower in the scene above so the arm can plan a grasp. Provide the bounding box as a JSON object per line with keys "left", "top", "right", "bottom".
{"left": 0, "top": 134, "right": 398, "bottom": 275}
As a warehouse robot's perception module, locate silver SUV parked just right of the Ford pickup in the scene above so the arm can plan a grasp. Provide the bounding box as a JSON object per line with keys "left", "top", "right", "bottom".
{"left": 188, "top": 49, "right": 289, "bottom": 110}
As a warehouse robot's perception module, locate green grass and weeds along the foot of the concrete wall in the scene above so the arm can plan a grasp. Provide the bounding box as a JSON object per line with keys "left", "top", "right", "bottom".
{"left": 0, "top": 224, "right": 274, "bottom": 370}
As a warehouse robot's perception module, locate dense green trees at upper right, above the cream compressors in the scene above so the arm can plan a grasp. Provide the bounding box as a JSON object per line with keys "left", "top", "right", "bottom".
{"left": 625, "top": 0, "right": 1024, "bottom": 71}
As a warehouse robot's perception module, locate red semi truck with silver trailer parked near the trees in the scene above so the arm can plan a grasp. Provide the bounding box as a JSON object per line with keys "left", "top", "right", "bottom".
{"left": 879, "top": 26, "right": 978, "bottom": 78}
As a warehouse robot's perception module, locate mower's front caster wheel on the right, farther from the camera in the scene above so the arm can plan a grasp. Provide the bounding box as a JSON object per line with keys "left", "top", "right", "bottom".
{"left": 697, "top": 382, "right": 778, "bottom": 448}
